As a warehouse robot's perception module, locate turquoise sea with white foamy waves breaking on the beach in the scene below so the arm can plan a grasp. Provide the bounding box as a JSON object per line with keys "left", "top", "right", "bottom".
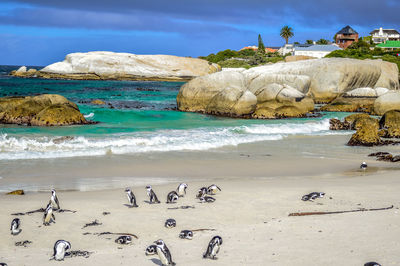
{"left": 0, "top": 68, "right": 350, "bottom": 160}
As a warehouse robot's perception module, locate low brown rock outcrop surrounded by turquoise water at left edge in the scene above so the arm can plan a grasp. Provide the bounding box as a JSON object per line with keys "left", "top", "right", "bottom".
{"left": 0, "top": 94, "right": 91, "bottom": 126}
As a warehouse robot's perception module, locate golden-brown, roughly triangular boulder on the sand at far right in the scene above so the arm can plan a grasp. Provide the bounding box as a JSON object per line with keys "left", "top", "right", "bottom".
{"left": 347, "top": 118, "right": 383, "bottom": 146}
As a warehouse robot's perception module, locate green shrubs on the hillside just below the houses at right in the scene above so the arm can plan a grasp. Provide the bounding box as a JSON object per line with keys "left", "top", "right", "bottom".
{"left": 326, "top": 40, "right": 400, "bottom": 69}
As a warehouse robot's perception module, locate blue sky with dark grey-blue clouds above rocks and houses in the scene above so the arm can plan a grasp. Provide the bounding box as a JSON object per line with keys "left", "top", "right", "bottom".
{"left": 0, "top": 0, "right": 400, "bottom": 66}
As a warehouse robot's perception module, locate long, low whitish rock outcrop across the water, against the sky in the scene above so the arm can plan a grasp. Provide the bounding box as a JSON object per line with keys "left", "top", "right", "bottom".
{"left": 11, "top": 52, "right": 220, "bottom": 81}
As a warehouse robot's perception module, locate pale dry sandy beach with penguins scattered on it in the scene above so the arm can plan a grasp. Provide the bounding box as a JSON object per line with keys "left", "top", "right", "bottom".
{"left": 0, "top": 136, "right": 400, "bottom": 265}
